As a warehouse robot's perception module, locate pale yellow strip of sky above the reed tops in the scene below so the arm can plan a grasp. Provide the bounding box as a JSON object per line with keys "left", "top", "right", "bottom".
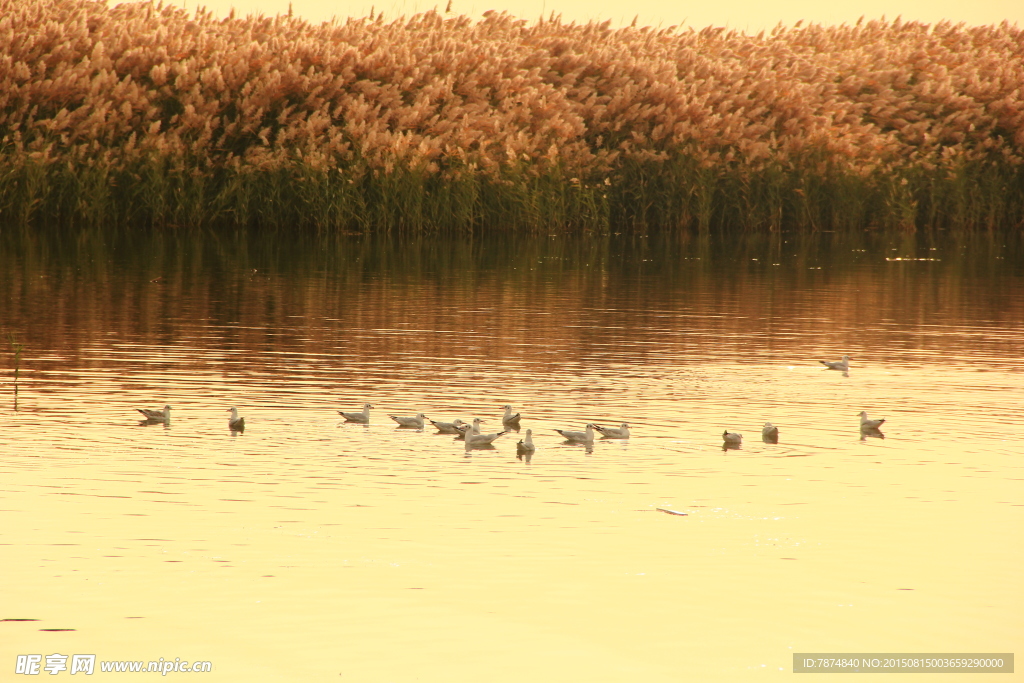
{"left": 184, "top": 0, "right": 1024, "bottom": 33}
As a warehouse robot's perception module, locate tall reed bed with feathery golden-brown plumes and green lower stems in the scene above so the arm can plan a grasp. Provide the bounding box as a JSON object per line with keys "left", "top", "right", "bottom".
{"left": 0, "top": 0, "right": 1024, "bottom": 230}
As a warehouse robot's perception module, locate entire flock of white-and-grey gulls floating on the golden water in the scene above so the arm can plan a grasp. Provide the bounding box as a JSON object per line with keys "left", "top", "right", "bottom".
{"left": 135, "top": 355, "right": 885, "bottom": 450}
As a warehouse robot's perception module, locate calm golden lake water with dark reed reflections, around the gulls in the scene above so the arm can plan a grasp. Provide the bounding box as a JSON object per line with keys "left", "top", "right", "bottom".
{"left": 0, "top": 228, "right": 1024, "bottom": 682}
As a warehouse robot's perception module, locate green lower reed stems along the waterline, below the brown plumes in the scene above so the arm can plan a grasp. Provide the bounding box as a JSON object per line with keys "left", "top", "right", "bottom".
{"left": 0, "top": 154, "right": 1024, "bottom": 232}
